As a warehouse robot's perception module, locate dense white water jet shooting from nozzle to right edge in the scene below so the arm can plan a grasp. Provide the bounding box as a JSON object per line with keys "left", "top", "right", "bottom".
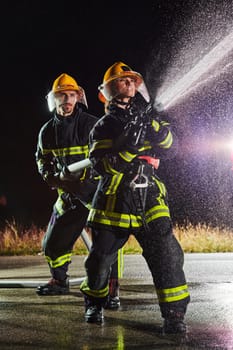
{"left": 156, "top": 31, "right": 233, "bottom": 110}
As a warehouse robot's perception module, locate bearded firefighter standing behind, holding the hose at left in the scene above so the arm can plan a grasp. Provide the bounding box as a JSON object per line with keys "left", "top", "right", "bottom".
{"left": 36, "top": 73, "right": 123, "bottom": 308}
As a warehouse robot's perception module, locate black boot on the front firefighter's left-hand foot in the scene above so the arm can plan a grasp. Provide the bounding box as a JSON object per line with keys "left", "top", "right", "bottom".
{"left": 84, "top": 295, "right": 104, "bottom": 323}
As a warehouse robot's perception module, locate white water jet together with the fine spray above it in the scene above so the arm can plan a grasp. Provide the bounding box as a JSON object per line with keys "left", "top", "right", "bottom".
{"left": 156, "top": 1, "right": 233, "bottom": 109}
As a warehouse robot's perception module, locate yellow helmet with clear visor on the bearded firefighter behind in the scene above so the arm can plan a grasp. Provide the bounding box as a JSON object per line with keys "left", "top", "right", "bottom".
{"left": 46, "top": 73, "right": 88, "bottom": 112}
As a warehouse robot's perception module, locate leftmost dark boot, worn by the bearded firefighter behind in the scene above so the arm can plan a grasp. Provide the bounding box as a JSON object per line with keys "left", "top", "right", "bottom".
{"left": 36, "top": 278, "right": 69, "bottom": 295}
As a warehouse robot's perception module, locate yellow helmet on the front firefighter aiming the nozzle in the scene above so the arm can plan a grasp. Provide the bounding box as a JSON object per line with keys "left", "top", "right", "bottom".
{"left": 98, "top": 62, "right": 143, "bottom": 102}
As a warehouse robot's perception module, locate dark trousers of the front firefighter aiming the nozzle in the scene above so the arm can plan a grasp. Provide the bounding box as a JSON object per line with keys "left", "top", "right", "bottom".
{"left": 80, "top": 217, "right": 190, "bottom": 318}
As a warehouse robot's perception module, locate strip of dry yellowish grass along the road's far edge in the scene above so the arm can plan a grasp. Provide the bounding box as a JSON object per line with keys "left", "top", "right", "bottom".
{"left": 0, "top": 220, "right": 233, "bottom": 256}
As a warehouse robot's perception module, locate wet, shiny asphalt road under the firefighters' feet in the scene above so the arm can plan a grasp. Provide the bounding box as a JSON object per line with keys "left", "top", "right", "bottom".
{"left": 0, "top": 253, "right": 233, "bottom": 350}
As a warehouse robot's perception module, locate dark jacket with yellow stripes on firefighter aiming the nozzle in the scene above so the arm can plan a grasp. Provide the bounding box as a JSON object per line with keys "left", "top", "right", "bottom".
{"left": 88, "top": 100, "right": 176, "bottom": 229}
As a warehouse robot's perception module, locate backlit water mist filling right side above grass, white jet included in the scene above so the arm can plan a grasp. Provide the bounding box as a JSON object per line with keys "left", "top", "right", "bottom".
{"left": 147, "top": 1, "right": 233, "bottom": 227}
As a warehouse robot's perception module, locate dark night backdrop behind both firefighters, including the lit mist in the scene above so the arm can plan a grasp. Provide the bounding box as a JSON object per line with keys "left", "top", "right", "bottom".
{"left": 0, "top": 0, "right": 233, "bottom": 226}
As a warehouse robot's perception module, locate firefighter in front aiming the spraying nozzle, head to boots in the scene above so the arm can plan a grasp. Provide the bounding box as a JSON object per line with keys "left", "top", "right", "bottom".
{"left": 80, "top": 62, "right": 190, "bottom": 333}
